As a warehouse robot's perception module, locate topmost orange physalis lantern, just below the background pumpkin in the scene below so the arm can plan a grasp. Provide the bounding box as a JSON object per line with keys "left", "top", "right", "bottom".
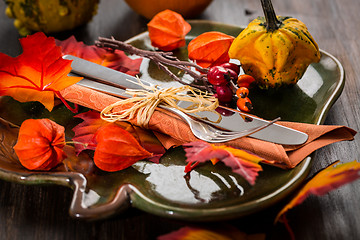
{"left": 147, "top": 10, "right": 191, "bottom": 51}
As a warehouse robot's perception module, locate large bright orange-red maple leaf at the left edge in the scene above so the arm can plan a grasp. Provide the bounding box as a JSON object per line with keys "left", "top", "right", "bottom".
{"left": 0, "top": 32, "right": 82, "bottom": 111}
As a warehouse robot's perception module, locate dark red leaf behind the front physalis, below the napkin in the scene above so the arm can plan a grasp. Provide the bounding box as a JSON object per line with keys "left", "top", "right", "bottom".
{"left": 72, "top": 111, "right": 165, "bottom": 154}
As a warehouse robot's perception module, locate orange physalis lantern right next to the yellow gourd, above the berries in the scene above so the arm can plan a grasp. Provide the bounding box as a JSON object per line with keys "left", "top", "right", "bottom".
{"left": 188, "top": 31, "right": 234, "bottom": 68}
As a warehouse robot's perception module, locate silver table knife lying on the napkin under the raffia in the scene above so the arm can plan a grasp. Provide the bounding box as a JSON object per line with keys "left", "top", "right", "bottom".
{"left": 63, "top": 55, "right": 308, "bottom": 145}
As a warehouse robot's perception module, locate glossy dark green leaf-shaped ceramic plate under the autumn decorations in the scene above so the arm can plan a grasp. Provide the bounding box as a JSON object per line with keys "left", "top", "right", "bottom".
{"left": 0, "top": 21, "right": 344, "bottom": 221}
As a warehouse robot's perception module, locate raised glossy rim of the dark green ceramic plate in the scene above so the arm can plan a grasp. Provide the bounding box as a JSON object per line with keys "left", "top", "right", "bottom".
{"left": 0, "top": 20, "right": 345, "bottom": 221}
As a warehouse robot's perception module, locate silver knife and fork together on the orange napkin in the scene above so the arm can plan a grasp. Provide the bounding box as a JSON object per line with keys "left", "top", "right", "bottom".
{"left": 63, "top": 55, "right": 308, "bottom": 145}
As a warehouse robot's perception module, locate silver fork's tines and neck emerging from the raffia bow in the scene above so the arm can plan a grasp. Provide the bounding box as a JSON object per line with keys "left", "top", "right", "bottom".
{"left": 159, "top": 105, "right": 280, "bottom": 143}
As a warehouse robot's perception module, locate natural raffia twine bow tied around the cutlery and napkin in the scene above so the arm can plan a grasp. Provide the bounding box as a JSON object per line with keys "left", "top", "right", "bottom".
{"left": 100, "top": 80, "right": 221, "bottom": 128}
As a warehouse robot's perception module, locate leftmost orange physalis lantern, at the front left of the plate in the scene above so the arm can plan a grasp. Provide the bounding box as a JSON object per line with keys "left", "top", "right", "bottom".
{"left": 14, "top": 119, "right": 66, "bottom": 170}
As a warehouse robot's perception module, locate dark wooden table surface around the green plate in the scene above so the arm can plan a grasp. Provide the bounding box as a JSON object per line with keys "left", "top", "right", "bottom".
{"left": 0, "top": 0, "right": 360, "bottom": 240}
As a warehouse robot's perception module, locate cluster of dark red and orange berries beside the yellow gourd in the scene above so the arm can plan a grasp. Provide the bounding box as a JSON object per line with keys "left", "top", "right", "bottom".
{"left": 207, "top": 63, "right": 255, "bottom": 112}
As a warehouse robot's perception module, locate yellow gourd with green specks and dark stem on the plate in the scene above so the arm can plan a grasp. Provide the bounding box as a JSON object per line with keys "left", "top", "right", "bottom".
{"left": 229, "top": 0, "right": 320, "bottom": 89}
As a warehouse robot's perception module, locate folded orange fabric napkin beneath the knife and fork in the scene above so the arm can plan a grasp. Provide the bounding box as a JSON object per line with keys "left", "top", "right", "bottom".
{"left": 61, "top": 84, "right": 356, "bottom": 168}
